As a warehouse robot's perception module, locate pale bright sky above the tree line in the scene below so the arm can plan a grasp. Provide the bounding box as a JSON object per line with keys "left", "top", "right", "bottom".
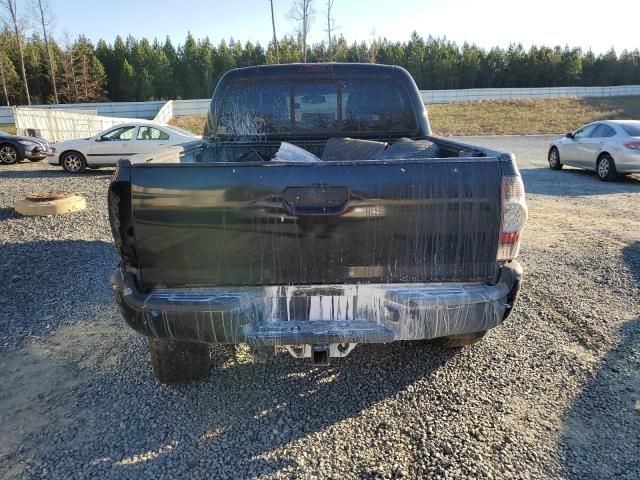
{"left": 51, "top": 0, "right": 640, "bottom": 53}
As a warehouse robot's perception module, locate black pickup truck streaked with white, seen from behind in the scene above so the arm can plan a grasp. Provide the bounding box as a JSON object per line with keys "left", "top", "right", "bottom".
{"left": 109, "top": 64, "right": 527, "bottom": 383}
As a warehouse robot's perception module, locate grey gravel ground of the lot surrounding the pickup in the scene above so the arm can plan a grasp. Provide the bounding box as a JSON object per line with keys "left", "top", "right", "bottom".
{"left": 0, "top": 137, "right": 640, "bottom": 479}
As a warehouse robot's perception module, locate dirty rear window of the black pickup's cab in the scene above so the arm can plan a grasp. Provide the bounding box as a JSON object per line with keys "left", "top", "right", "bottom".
{"left": 207, "top": 77, "right": 417, "bottom": 139}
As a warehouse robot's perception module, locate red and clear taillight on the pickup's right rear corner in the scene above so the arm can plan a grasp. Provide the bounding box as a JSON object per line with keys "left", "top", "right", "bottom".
{"left": 497, "top": 175, "right": 528, "bottom": 260}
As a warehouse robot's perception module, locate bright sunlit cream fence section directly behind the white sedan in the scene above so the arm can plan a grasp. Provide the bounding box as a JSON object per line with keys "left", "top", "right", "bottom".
{"left": 14, "top": 107, "right": 145, "bottom": 142}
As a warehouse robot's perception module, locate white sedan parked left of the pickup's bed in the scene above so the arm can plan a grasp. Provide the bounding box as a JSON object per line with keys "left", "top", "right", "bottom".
{"left": 47, "top": 122, "right": 201, "bottom": 173}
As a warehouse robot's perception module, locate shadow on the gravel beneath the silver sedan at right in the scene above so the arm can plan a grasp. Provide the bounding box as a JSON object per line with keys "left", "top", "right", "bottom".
{"left": 520, "top": 168, "right": 640, "bottom": 197}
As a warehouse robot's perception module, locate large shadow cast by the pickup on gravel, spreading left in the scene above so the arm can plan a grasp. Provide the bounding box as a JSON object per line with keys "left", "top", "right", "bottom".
{"left": 0, "top": 241, "right": 465, "bottom": 479}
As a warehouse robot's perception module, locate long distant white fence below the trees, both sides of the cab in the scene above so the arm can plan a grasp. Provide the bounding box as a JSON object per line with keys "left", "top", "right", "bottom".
{"left": 0, "top": 85, "right": 640, "bottom": 125}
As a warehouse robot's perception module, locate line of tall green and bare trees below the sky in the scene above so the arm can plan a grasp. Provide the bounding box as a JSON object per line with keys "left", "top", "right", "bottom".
{"left": 0, "top": 0, "right": 640, "bottom": 105}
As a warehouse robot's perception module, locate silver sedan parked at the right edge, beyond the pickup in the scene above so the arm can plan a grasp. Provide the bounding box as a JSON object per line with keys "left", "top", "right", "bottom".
{"left": 548, "top": 120, "right": 640, "bottom": 180}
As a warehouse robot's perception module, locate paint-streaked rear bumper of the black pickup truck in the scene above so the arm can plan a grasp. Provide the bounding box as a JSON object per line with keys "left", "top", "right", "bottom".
{"left": 111, "top": 261, "right": 522, "bottom": 346}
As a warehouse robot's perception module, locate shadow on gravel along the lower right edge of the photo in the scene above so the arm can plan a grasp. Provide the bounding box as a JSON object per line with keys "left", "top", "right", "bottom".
{"left": 561, "top": 242, "right": 640, "bottom": 480}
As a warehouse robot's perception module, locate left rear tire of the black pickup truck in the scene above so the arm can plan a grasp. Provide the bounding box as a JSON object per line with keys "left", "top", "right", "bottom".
{"left": 149, "top": 337, "right": 211, "bottom": 384}
